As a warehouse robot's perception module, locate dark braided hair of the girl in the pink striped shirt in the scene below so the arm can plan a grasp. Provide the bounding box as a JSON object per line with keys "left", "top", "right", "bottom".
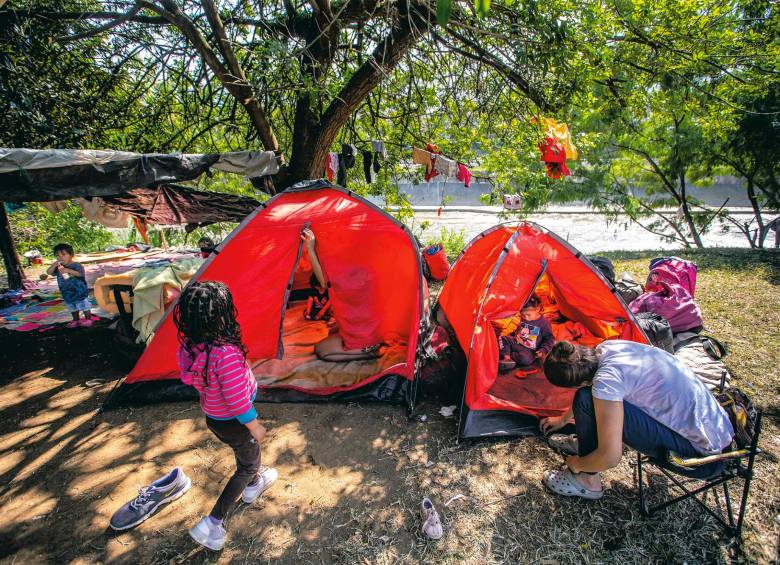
{"left": 173, "top": 281, "right": 246, "bottom": 385}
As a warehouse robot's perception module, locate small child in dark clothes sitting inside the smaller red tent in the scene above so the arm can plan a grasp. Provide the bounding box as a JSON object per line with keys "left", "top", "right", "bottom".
{"left": 498, "top": 294, "right": 555, "bottom": 373}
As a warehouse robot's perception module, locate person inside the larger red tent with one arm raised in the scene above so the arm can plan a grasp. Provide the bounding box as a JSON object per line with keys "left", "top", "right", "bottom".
{"left": 301, "top": 228, "right": 382, "bottom": 361}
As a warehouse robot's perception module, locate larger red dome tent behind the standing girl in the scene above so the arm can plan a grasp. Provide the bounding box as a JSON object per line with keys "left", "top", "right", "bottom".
{"left": 107, "top": 181, "right": 427, "bottom": 406}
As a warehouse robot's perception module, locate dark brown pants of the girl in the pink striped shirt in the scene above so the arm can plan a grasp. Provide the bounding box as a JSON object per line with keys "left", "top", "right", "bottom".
{"left": 206, "top": 417, "right": 260, "bottom": 520}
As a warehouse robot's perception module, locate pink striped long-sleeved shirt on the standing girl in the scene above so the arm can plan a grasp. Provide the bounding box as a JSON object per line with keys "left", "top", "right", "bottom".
{"left": 179, "top": 344, "right": 257, "bottom": 424}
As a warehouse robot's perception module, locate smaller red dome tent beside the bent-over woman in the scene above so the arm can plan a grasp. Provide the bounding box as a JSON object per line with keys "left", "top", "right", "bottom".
{"left": 439, "top": 222, "right": 649, "bottom": 438}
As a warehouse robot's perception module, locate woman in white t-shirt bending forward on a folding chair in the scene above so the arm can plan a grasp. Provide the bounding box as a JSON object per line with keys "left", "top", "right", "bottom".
{"left": 540, "top": 340, "right": 734, "bottom": 499}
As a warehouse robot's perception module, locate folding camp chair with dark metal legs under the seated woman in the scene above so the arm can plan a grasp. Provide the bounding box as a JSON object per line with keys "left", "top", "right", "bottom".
{"left": 637, "top": 410, "right": 761, "bottom": 544}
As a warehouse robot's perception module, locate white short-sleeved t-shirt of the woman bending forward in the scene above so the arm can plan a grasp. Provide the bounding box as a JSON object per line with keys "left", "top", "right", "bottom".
{"left": 591, "top": 340, "right": 734, "bottom": 455}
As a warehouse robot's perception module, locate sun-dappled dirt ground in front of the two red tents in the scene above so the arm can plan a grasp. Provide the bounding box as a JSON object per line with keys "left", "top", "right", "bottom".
{"left": 0, "top": 252, "right": 780, "bottom": 565}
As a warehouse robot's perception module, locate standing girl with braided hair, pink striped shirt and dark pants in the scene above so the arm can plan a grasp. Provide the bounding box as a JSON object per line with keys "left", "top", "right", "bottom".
{"left": 173, "top": 281, "right": 277, "bottom": 551}
